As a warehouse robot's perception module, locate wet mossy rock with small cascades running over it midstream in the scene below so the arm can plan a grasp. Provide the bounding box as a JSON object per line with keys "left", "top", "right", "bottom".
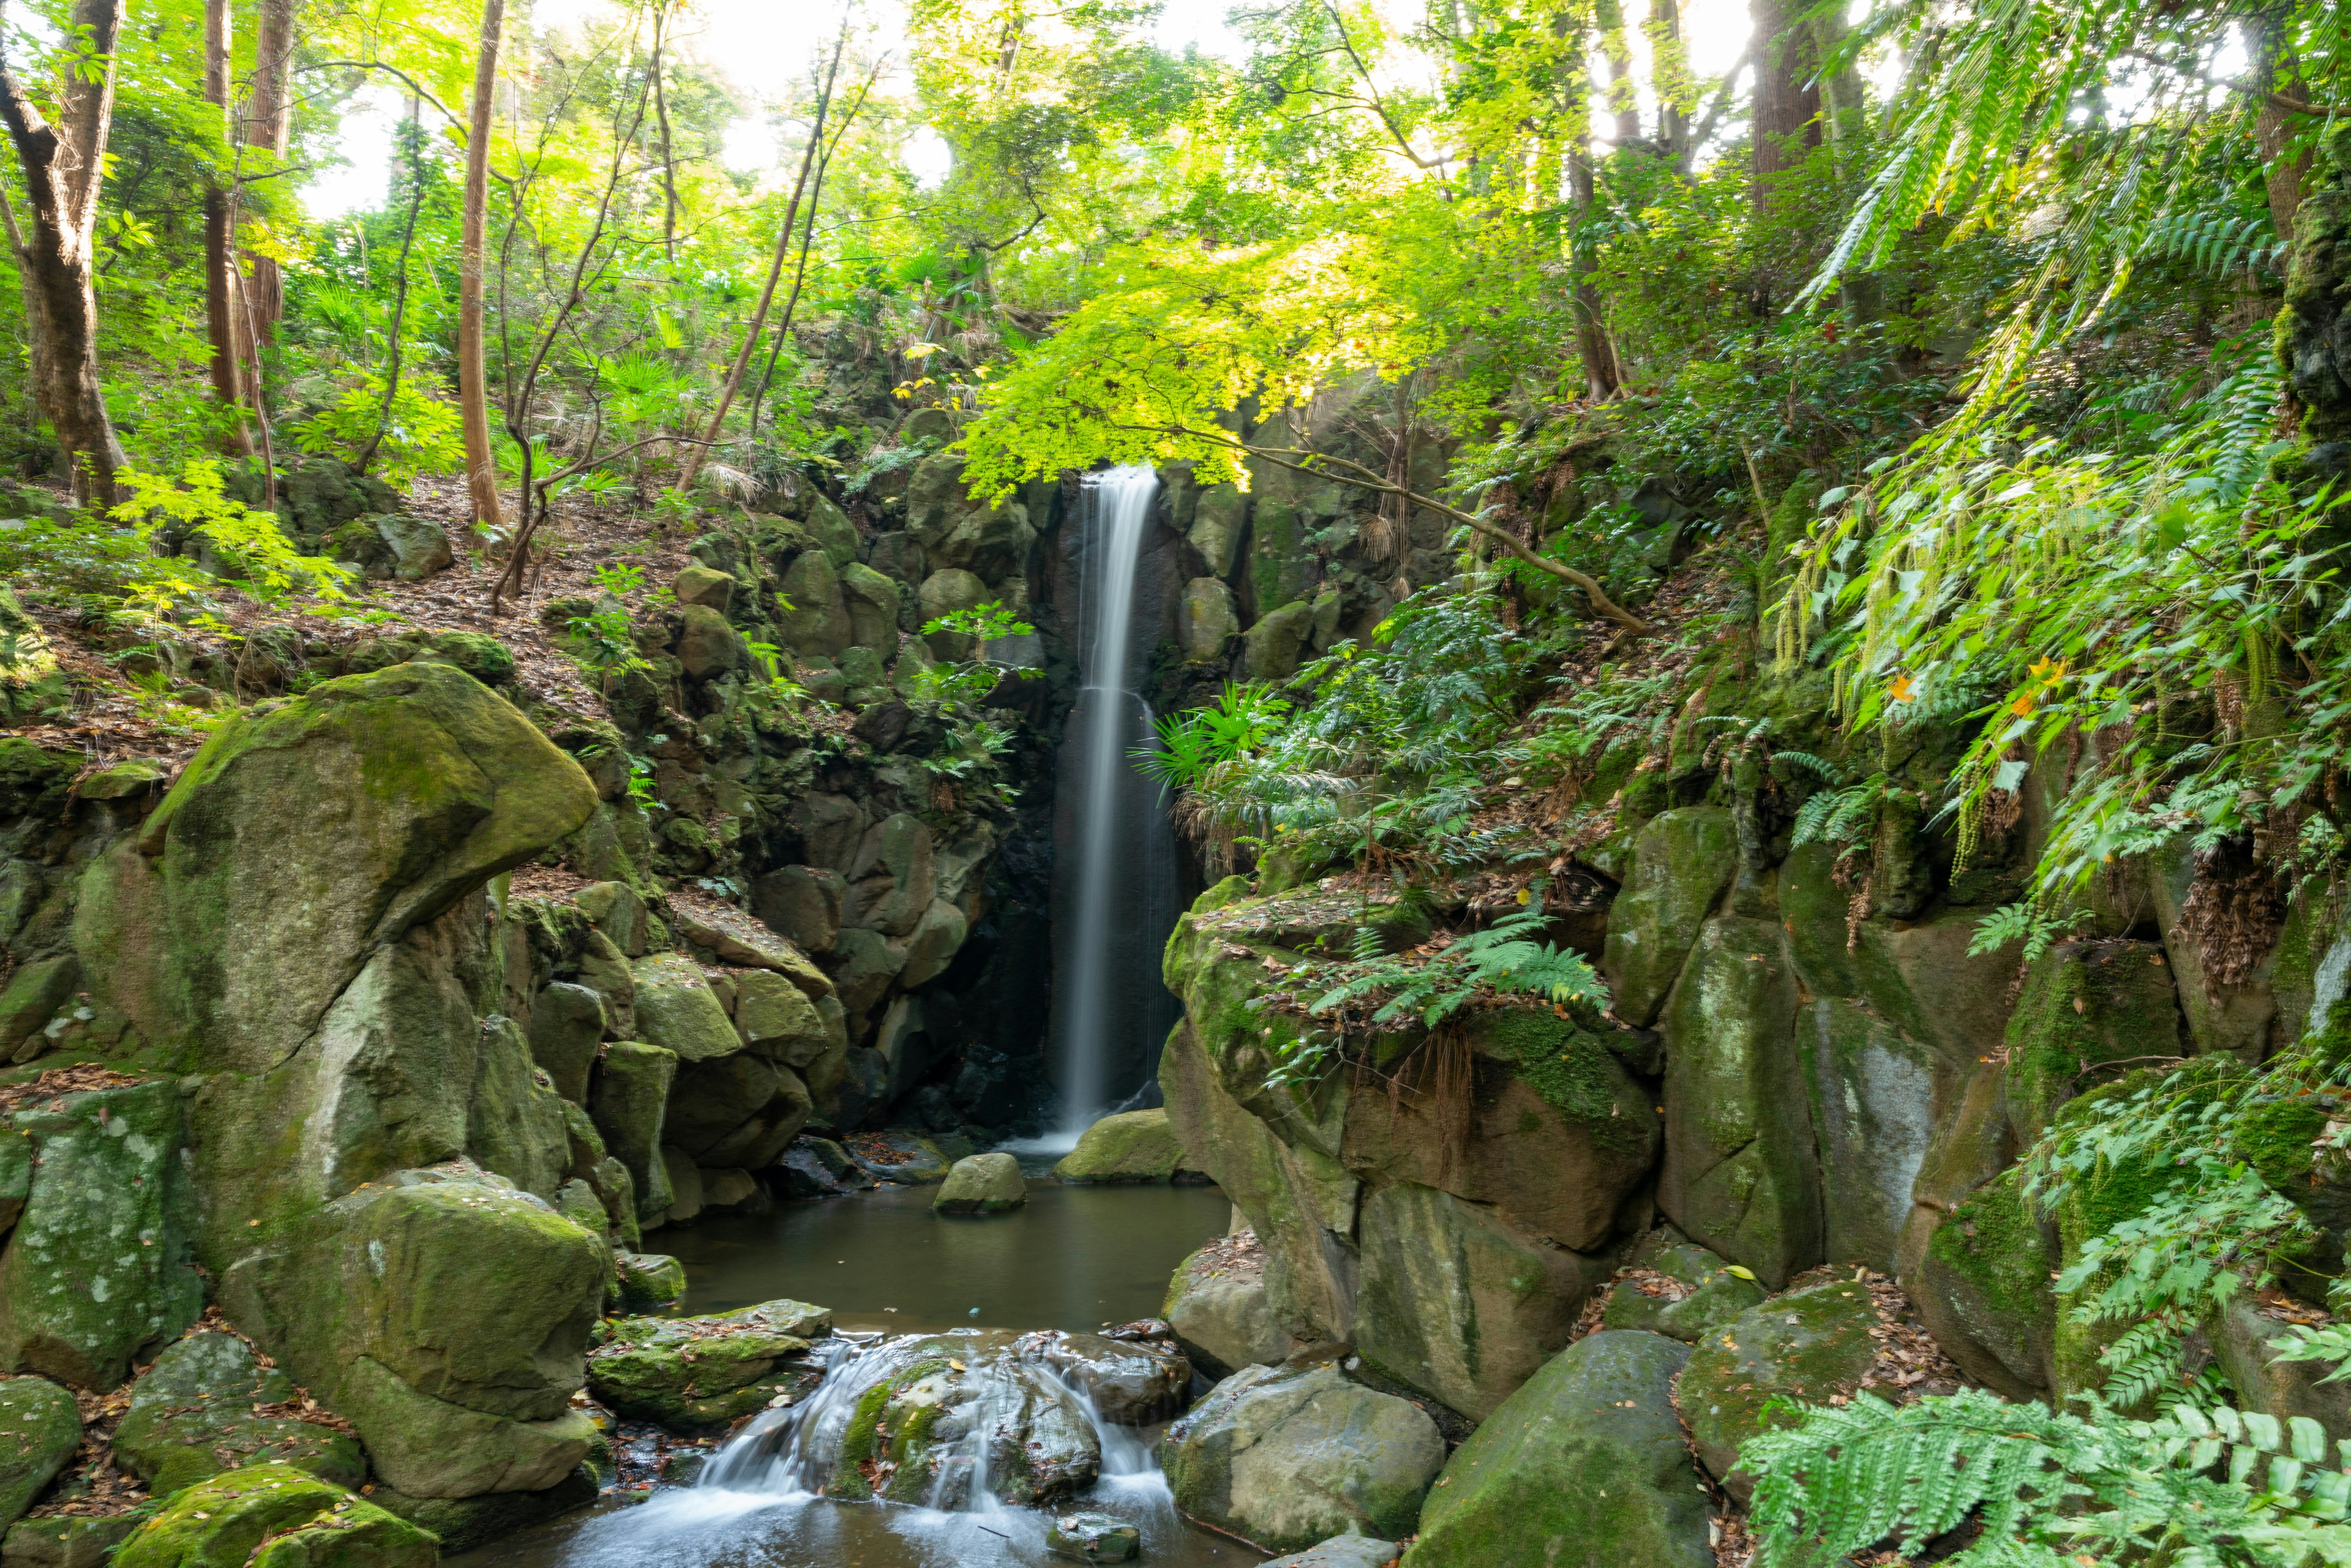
{"left": 814, "top": 1333, "right": 1103, "bottom": 1509}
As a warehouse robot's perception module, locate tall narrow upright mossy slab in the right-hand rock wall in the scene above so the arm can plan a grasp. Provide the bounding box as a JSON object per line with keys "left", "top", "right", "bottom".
{"left": 1655, "top": 921, "right": 1822, "bottom": 1288}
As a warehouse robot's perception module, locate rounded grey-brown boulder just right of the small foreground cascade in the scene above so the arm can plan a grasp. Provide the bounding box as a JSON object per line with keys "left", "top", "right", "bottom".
{"left": 1161, "top": 1366, "right": 1446, "bottom": 1551}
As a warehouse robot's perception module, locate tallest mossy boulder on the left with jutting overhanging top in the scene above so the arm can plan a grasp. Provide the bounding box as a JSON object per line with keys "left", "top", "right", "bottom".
{"left": 75, "top": 663, "right": 597, "bottom": 1274}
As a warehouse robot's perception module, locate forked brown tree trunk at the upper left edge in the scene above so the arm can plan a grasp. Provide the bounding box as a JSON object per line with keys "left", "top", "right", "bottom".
{"left": 0, "top": 0, "right": 125, "bottom": 506}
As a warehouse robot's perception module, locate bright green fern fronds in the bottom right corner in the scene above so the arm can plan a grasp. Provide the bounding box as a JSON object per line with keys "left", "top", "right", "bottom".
{"left": 1740, "top": 1389, "right": 2351, "bottom": 1568}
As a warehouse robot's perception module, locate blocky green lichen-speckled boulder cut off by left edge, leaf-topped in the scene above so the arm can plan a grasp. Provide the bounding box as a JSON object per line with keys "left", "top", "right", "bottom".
{"left": 0, "top": 1081, "right": 204, "bottom": 1392}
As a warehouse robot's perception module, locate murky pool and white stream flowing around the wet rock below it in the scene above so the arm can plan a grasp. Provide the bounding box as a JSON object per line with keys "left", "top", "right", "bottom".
{"left": 447, "top": 1182, "right": 1260, "bottom": 1568}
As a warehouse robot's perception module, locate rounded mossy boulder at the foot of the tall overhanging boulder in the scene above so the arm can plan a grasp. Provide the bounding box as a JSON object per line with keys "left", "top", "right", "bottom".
{"left": 221, "top": 1164, "right": 611, "bottom": 1498}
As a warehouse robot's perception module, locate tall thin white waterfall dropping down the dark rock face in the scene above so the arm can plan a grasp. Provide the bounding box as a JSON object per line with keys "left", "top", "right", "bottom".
{"left": 1053, "top": 468, "right": 1183, "bottom": 1142}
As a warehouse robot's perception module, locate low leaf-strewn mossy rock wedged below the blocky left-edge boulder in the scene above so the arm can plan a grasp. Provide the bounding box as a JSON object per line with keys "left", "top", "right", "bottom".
{"left": 115, "top": 1333, "right": 367, "bottom": 1498}
